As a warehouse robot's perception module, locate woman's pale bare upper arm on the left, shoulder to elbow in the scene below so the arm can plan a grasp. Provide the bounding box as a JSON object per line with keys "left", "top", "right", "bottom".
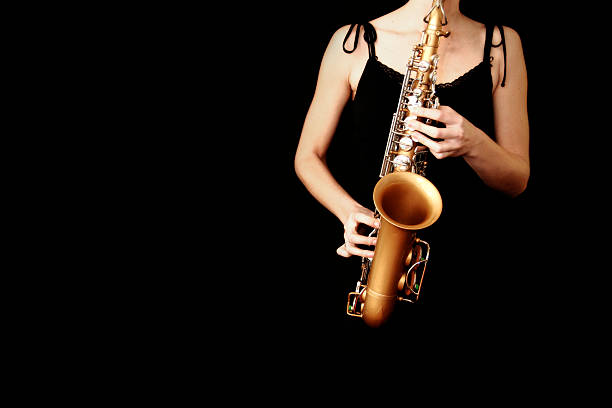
{"left": 296, "top": 26, "right": 355, "bottom": 158}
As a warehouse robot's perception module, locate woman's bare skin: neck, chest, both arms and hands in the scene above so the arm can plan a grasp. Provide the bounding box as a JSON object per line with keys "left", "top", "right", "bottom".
{"left": 295, "top": 0, "right": 530, "bottom": 258}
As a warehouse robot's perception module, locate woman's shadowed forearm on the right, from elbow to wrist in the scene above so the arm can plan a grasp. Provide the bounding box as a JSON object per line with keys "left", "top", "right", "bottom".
{"left": 463, "top": 133, "right": 530, "bottom": 197}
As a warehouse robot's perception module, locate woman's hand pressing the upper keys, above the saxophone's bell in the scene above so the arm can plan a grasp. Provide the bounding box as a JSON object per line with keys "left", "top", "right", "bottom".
{"left": 405, "top": 105, "right": 486, "bottom": 159}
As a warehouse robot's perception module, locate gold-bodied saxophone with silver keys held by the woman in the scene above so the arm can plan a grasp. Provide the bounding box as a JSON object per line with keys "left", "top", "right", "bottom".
{"left": 346, "top": 0, "right": 450, "bottom": 327}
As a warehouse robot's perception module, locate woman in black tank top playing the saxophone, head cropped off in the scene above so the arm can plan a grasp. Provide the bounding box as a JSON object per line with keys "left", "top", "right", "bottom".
{"left": 295, "top": 0, "right": 530, "bottom": 322}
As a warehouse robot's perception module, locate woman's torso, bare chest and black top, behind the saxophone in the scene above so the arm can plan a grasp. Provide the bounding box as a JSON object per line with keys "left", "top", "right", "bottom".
{"left": 329, "top": 17, "right": 507, "bottom": 307}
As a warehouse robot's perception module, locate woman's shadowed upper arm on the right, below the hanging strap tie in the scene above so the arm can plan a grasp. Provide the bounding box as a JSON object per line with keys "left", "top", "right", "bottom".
{"left": 491, "top": 27, "right": 529, "bottom": 165}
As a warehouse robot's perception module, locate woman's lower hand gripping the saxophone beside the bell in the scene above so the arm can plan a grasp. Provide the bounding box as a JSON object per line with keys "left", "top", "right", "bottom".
{"left": 336, "top": 207, "right": 380, "bottom": 258}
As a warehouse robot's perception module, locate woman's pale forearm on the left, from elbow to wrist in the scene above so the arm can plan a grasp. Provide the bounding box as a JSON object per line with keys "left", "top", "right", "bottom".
{"left": 295, "top": 154, "right": 361, "bottom": 224}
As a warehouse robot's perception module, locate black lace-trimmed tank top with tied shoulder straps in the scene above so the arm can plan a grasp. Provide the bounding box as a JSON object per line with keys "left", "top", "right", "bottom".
{"left": 342, "top": 23, "right": 509, "bottom": 314}
